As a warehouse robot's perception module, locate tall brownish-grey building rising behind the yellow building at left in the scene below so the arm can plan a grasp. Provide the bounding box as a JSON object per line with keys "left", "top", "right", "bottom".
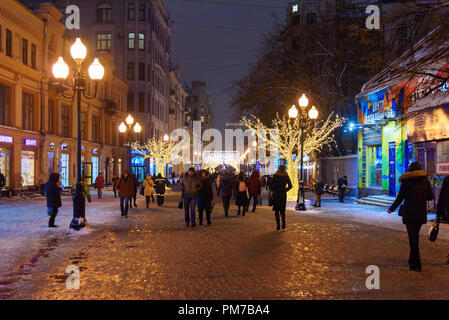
{"left": 27, "top": 0, "right": 172, "bottom": 139}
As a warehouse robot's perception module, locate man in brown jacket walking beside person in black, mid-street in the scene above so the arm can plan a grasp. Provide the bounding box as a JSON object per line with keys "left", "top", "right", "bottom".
{"left": 181, "top": 167, "right": 201, "bottom": 228}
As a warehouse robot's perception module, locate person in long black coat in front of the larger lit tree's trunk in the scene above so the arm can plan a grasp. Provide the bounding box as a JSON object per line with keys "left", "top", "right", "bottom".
{"left": 271, "top": 165, "right": 293, "bottom": 230}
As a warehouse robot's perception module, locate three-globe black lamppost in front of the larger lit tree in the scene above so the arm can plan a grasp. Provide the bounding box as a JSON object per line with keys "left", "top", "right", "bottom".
{"left": 288, "top": 94, "right": 318, "bottom": 211}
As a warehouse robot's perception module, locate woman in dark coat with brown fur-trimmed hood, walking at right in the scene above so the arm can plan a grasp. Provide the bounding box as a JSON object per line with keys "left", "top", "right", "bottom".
{"left": 388, "top": 162, "right": 434, "bottom": 271}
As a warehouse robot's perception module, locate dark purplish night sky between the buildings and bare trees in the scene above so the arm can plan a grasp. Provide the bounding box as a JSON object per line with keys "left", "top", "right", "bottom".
{"left": 164, "top": 0, "right": 292, "bottom": 130}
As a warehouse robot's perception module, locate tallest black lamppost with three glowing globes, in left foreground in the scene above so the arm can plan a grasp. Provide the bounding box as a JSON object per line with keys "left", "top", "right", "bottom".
{"left": 53, "top": 38, "right": 104, "bottom": 230}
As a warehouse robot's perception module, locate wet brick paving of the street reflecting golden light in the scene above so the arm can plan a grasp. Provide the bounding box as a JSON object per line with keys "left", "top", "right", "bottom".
{"left": 0, "top": 194, "right": 449, "bottom": 299}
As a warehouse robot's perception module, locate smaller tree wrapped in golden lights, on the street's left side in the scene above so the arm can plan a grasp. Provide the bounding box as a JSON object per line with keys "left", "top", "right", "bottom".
{"left": 131, "top": 136, "right": 182, "bottom": 178}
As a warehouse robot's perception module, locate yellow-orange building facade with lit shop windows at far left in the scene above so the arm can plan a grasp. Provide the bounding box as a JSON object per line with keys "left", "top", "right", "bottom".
{"left": 0, "top": 0, "right": 128, "bottom": 190}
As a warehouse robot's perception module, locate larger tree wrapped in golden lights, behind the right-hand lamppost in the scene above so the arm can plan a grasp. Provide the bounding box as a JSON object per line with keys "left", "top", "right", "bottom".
{"left": 240, "top": 113, "right": 345, "bottom": 200}
